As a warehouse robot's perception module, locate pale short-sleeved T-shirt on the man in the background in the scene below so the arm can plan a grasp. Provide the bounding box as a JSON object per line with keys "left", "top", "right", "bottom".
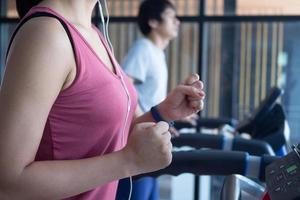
{"left": 122, "top": 38, "right": 168, "bottom": 112}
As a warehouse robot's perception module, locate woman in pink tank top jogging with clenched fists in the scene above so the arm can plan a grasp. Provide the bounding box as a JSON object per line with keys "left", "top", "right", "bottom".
{"left": 0, "top": 0, "right": 205, "bottom": 200}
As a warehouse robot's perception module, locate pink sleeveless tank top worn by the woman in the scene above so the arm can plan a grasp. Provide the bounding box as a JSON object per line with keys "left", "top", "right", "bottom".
{"left": 20, "top": 6, "right": 137, "bottom": 200}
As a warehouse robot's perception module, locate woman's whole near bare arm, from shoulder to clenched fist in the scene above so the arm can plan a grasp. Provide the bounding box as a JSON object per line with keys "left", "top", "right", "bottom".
{"left": 0, "top": 18, "right": 171, "bottom": 200}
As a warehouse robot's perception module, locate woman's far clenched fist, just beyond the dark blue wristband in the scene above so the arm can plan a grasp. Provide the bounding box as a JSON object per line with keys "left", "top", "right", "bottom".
{"left": 158, "top": 74, "right": 205, "bottom": 121}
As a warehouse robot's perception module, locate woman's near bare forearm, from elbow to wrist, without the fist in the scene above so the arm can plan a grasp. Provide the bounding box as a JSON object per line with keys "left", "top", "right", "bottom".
{"left": 0, "top": 151, "right": 137, "bottom": 200}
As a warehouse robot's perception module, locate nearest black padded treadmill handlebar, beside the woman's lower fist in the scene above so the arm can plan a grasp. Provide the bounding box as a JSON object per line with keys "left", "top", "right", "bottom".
{"left": 133, "top": 150, "right": 277, "bottom": 181}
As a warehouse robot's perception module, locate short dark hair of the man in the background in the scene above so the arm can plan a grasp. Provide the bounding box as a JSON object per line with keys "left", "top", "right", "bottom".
{"left": 138, "top": 0, "right": 175, "bottom": 35}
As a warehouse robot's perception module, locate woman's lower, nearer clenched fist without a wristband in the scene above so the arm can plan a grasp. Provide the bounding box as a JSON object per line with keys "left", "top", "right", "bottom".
{"left": 123, "top": 122, "right": 172, "bottom": 175}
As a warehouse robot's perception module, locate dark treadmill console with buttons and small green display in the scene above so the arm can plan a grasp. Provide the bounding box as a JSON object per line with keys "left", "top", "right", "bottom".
{"left": 266, "top": 145, "right": 300, "bottom": 200}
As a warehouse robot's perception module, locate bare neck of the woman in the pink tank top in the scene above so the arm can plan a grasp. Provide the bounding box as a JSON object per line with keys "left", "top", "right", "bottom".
{"left": 39, "top": 0, "right": 97, "bottom": 28}
